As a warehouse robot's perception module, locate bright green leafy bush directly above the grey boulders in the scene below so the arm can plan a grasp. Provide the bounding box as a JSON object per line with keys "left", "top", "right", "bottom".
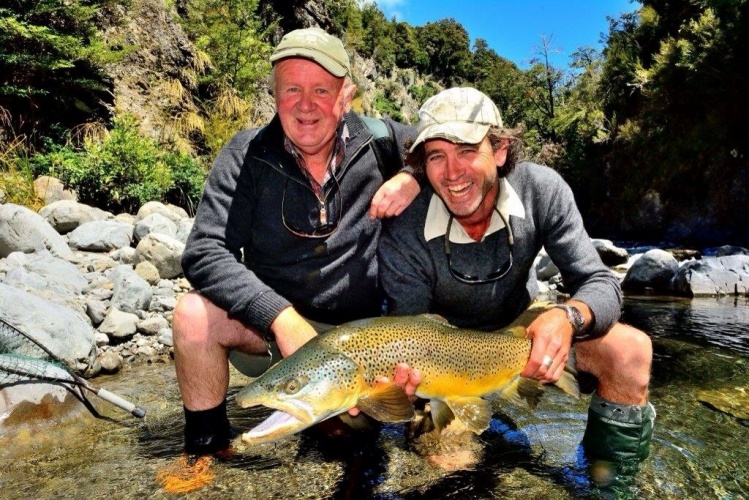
{"left": 31, "top": 115, "right": 204, "bottom": 213}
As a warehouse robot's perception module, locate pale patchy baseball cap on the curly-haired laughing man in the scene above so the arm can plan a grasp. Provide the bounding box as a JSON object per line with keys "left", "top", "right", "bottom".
{"left": 409, "top": 87, "right": 502, "bottom": 152}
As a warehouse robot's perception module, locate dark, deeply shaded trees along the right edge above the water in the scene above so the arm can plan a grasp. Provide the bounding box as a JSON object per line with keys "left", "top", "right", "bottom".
{"left": 584, "top": 0, "right": 749, "bottom": 241}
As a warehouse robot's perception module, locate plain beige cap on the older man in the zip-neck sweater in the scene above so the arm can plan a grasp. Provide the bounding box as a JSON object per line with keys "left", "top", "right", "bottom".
{"left": 270, "top": 28, "right": 351, "bottom": 78}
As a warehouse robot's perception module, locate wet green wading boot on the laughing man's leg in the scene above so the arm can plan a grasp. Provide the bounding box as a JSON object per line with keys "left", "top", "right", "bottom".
{"left": 582, "top": 393, "right": 655, "bottom": 489}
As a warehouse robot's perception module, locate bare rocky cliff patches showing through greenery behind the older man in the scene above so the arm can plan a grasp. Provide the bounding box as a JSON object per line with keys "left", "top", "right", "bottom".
{"left": 102, "top": 0, "right": 424, "bottom": 145}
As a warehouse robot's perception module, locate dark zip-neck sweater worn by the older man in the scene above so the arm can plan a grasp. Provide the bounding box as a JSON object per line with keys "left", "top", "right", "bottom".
{"left": 182, "top": 113, "right": 413, "bottom": 332}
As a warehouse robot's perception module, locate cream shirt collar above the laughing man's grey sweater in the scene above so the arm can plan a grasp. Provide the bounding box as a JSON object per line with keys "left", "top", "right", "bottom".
{"left": 424, "top": 178, "right": 525, "bottom": 243}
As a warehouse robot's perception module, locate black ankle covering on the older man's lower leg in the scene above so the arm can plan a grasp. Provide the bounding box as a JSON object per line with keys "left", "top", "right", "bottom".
{"left": 184, "top": 400, "right": 236, "bottom": 455}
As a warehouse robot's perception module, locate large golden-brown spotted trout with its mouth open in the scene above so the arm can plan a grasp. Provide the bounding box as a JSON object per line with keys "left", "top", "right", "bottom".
{"left": 236, "top": 314, "right": 579, "bottom": 444}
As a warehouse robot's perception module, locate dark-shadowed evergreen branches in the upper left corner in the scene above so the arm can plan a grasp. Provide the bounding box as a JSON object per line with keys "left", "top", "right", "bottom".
{"left": 0, "top": 0, "right": 124, "bottom": 143}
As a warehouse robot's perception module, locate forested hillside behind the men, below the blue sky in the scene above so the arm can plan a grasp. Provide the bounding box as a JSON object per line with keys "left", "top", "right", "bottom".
{"left": 0, "top": 0, "right": 749, "bottom": 245}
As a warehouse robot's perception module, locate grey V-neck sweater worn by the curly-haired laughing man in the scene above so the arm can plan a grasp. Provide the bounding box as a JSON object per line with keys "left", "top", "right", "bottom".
{"left": 379, "top": 162, "right": 621, "bottom": 332}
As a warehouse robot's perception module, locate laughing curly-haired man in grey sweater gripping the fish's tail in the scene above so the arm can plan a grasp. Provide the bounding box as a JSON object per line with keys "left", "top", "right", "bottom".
{"left": 379, "top": 88, "right": 655, "bottom": 480}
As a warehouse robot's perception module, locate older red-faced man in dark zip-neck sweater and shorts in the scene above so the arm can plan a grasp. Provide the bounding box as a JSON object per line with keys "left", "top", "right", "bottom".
{"left": 174, "top": 28, "right": 419, "bottom": 454}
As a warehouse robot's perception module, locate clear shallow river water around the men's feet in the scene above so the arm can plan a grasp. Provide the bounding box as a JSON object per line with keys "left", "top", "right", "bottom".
{"left": 0, "top": 297, "right": 749, "bottom": 499}
